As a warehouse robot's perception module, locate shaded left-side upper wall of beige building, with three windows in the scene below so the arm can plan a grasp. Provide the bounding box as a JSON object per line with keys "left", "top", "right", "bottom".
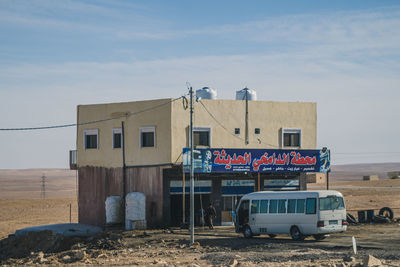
{"left": 77, "top": 99, "right": 173, "bottom": 167}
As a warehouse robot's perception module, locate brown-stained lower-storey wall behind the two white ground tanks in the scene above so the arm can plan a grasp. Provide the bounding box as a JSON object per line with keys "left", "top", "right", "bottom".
{"left": 78, "top": 167, "right": 165, "bottom": 227}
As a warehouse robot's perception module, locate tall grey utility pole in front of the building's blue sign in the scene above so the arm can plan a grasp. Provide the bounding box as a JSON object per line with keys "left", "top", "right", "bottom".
{"left": 189, "top": 86, "right": 194, "bottom": 245}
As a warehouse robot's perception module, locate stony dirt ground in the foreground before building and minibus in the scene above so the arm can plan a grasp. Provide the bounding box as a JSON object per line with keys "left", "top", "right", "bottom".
{"left": 0, "top": 223, "right": 400, "bottom": 266}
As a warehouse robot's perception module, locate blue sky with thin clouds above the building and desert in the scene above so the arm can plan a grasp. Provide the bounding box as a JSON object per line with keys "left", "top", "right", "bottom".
{"left": 0, "top": 0, "right": 400, "bottom": 169}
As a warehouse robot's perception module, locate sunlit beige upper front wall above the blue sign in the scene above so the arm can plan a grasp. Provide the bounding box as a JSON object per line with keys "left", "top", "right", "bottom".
{"left": 171, "top": 100, "right": 317, "bottom": 161}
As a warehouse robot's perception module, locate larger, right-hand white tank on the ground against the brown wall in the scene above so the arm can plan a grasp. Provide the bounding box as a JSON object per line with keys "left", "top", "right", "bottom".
{"left": 125, "top": 192, "right": 146, "bottom": 230}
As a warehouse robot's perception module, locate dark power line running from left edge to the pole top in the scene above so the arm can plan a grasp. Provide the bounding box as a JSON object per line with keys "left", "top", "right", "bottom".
{"left": 0, "top": 96, "right": 183, "bottom": 131}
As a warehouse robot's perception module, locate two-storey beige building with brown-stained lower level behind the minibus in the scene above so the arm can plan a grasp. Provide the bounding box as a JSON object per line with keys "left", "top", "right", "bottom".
{"left": 76, "top": 99, "right": 317, "bottom": 226}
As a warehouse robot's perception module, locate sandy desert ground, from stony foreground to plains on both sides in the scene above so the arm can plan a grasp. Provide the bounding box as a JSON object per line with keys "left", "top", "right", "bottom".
{"left": 0, "top": 164, "right": 400, "bottom": 266}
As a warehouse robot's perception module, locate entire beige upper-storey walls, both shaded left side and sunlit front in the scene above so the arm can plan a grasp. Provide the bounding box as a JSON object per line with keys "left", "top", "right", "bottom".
{"left": 77, "top": 99, "right": 317, "bottom": 170}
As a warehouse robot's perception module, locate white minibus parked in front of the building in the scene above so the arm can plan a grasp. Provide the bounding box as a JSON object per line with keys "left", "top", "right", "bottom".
{"left": 235, "top": 190, "right": 347, "bottom": 240}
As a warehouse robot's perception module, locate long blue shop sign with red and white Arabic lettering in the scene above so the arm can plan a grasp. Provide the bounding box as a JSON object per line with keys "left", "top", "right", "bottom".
{"left": 183, "top": 148, "right": 330, "bottom": 173}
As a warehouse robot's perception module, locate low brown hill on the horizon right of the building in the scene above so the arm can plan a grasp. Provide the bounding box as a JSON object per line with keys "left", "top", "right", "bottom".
{"left": 329, "top": 162, "right": 400, "bottom": 181}
